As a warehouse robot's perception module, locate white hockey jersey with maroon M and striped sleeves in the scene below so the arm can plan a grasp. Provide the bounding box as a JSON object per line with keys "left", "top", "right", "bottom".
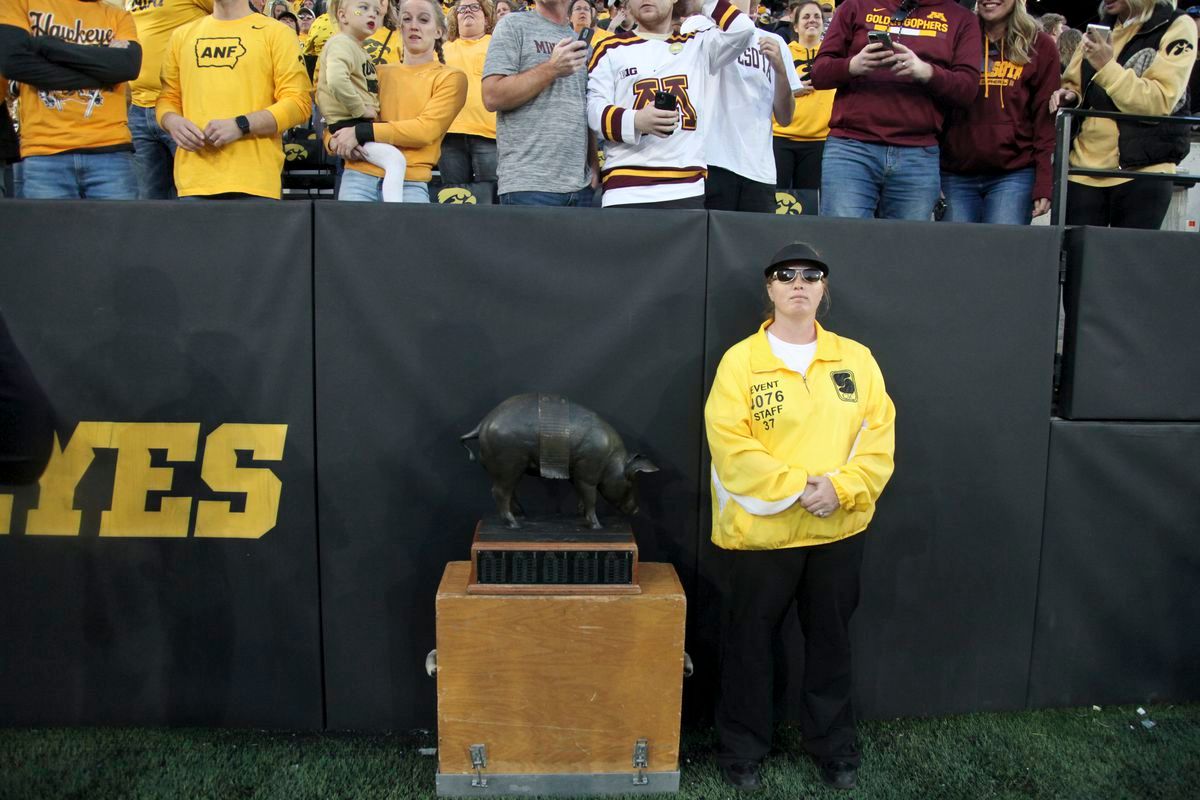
{"left": 588, "top": 0, "right": 753, "bottom": 205}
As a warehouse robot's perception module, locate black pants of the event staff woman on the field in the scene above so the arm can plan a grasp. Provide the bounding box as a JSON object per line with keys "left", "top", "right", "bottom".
{"left": 716, "top": 534, "right": 865, "bottom": 766}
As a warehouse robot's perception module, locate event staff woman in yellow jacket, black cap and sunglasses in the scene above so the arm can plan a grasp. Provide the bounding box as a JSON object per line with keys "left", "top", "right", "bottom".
{"left": 704, "top": 242, "right": 895, "bottom": 789}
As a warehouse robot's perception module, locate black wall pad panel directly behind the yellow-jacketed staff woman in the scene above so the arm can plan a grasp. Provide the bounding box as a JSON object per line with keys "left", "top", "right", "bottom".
{"left": 692, "top": 213, "right": 1060, "bottom": 716}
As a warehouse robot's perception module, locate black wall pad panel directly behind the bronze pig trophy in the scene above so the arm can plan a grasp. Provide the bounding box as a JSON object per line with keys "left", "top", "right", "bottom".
{"left": 316, "top": 204, "right": 707, "bottom": 728}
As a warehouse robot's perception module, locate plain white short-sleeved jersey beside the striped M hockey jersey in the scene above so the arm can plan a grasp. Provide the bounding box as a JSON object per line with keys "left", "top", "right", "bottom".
{"left": 704, "top": 29, "right": 800, "bottom": 186}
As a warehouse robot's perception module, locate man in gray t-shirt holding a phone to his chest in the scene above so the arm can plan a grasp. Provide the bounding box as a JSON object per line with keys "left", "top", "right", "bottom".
{"left": 484, "top": 0, "right": 595, "bottom": 205}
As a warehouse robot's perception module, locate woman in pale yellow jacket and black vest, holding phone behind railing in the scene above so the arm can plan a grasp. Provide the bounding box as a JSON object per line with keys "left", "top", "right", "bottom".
{"left": 1050, "top": 0, "right": 1196, "bottom": 228}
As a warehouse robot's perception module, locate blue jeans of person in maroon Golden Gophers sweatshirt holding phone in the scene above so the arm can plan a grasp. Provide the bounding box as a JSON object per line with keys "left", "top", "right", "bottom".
{"left": 821, "top": 137, "right": 941, "bottom": 221}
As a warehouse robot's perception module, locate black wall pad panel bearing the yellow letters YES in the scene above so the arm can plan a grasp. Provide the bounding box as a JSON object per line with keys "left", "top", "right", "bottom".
{"left": 0, "top": 200, "right": 323, "bottom": 729}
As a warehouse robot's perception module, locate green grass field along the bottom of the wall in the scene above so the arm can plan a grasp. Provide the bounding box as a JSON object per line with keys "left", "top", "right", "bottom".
{"left": 0, "top": 705, "right": 1200, "bottom": 800}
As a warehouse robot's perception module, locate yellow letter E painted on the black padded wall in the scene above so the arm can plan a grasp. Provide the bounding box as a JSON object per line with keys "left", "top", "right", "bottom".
{"left": 100, "top": 422, "right": 200, "bottom": 537}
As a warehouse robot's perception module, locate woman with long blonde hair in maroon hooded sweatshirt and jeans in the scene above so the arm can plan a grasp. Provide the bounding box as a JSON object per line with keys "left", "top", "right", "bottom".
{"left": 942, "top": 0, "right": 1058, "bottom": 225}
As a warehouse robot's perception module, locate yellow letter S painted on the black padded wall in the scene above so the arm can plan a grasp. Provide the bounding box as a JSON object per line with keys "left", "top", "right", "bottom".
{"left": 196, "top": 422, "right": 288, "bottom": 539}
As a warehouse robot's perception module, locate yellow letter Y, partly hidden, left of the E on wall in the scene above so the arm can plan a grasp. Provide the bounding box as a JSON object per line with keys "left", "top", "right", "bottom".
{"left": 25, "top": 422, "right": 113, "bottom": 536}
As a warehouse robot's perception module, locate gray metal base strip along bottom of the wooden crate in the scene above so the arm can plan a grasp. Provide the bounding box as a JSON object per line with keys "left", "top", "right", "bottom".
{"left": 437, "top": 770, "right": 679, "bottom": 798}
